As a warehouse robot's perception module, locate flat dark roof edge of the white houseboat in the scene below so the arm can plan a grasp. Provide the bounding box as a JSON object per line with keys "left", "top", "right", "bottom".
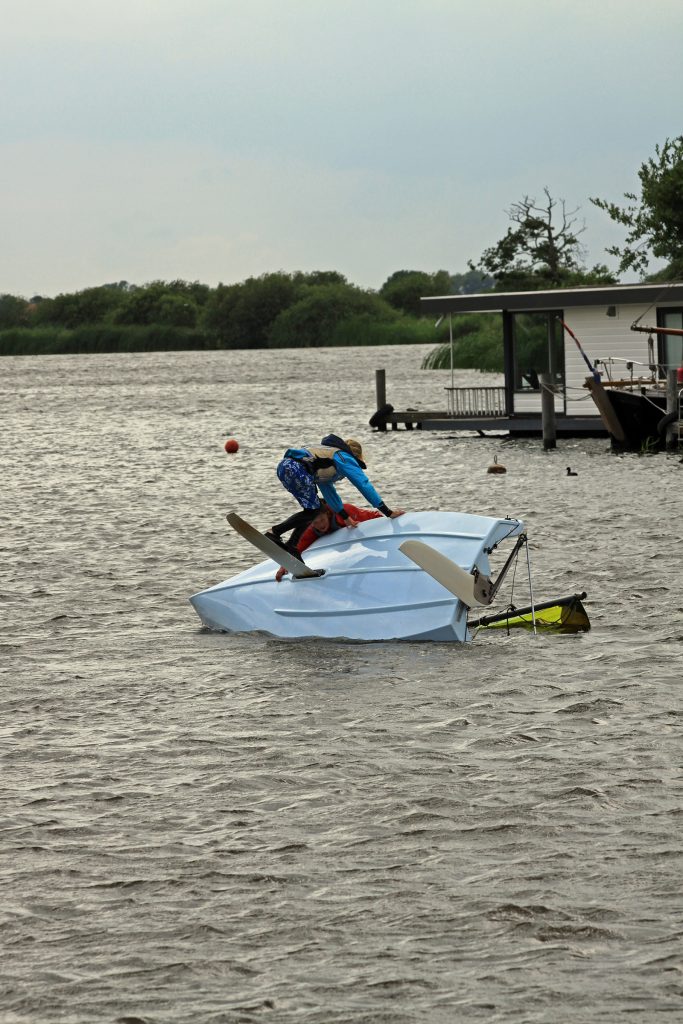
{"left": 420, "top": 284, "right": 683, "bottom": 315}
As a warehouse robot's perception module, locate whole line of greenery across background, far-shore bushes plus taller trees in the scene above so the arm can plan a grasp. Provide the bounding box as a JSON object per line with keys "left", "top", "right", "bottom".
{"left": 0, "top": 136, "right": 683, "bottom": 362}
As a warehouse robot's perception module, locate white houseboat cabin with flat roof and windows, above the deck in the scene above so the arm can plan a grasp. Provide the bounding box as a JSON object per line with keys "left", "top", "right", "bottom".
{"left": 421, "top": 283, "right": 683, "bottom": 424}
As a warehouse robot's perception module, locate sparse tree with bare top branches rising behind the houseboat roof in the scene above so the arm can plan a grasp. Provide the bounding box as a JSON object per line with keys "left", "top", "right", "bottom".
{"left": 468, "top": 187, "right": 614, "bottom": 291}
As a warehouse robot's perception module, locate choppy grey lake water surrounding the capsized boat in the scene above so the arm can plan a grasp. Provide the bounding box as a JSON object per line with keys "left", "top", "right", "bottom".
{"left": 0, "top": 348, "right": 683, "bottom": 1024}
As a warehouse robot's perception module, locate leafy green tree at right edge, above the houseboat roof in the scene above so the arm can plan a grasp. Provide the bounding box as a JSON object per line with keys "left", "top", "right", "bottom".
{"left": 591, "top": 135, "right": 683, "bottom": 280}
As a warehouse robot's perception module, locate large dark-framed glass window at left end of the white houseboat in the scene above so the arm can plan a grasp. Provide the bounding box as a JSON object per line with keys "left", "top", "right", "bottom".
{"left": 513, "top": 309, "right": 564, "bottom": 391}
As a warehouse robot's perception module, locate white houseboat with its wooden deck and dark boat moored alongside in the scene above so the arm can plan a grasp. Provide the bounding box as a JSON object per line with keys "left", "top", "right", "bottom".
{"left": 371, "top": 283, "right": 683, "bottom": 450}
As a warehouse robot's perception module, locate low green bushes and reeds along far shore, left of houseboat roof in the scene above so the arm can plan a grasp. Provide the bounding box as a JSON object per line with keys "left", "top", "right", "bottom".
{"left": 0, "top": 270, "right": 502, "bottom": 370}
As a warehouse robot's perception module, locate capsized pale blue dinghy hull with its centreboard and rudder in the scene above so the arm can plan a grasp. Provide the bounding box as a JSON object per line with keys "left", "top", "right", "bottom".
{"left": 190, "top": 512, "right": 561, "bottom": 642}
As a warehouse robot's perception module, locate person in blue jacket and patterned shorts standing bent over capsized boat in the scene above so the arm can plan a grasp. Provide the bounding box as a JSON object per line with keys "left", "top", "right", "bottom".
{"left": 265, "top": 434, "right": 403, "bottom": 558}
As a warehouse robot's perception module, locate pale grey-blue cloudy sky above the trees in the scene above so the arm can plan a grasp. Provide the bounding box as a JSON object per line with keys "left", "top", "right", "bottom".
{"left": 0, "top": 0, "right": 683, "bottom": 297}
